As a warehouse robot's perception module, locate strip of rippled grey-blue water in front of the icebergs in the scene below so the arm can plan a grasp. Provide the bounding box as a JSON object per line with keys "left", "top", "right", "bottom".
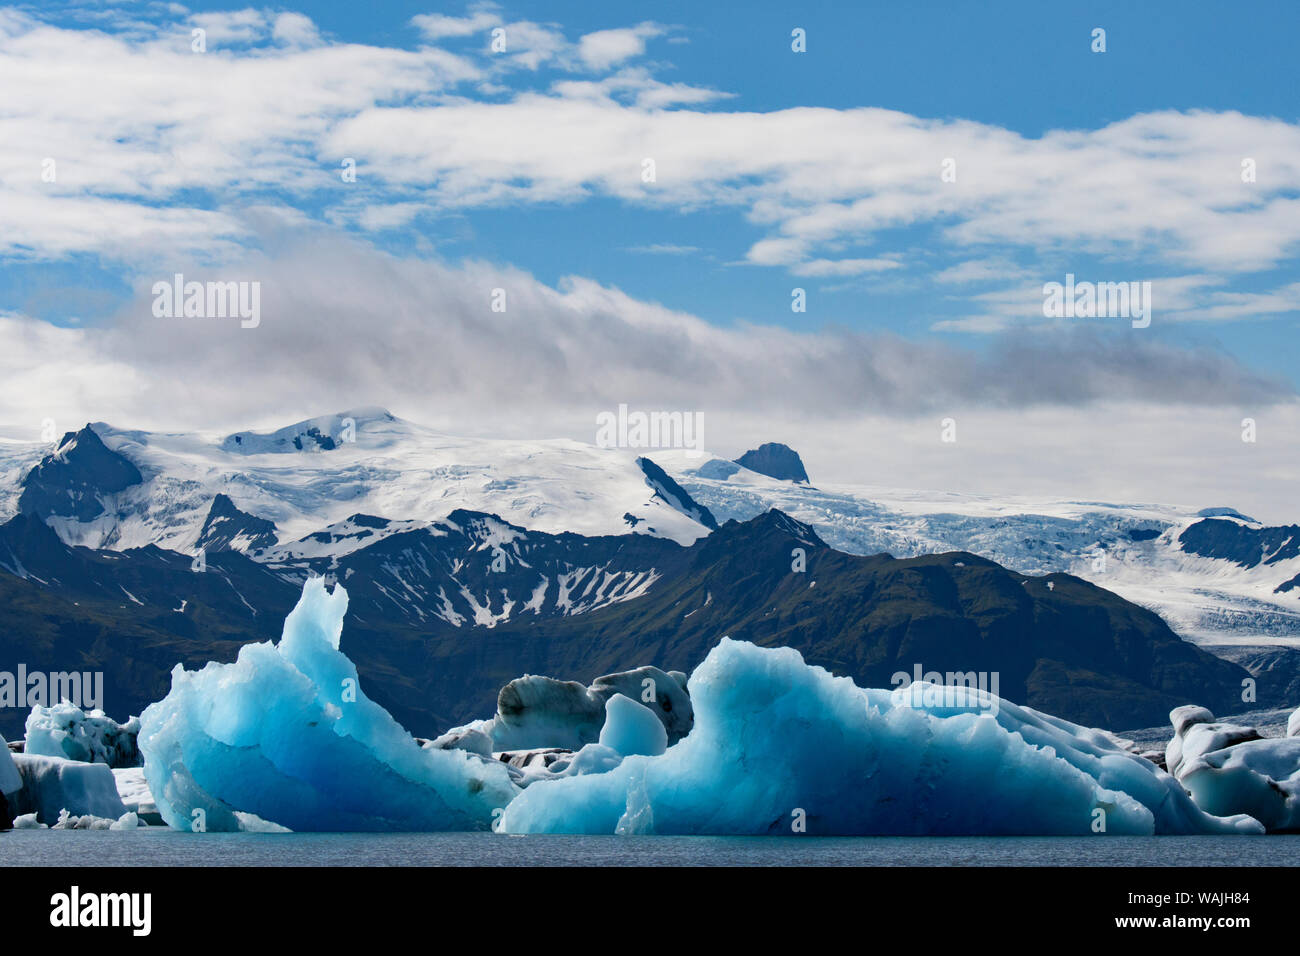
{"left": 0, "top": 827, "right": 1300, "bottom": 866}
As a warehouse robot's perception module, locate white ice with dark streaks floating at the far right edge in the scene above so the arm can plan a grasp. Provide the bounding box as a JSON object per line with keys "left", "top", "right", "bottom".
{"left": 1165, "top": 708, "right": 1300, "bottom": 831}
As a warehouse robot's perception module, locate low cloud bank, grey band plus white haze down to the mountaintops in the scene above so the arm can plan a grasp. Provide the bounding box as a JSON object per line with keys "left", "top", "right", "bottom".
{"left": 0, "top": 233, "right": 1300, "bottom": 519}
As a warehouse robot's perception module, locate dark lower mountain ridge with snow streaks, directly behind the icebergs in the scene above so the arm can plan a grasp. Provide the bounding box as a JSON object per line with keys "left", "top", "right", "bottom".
{"left": 0, "top": 502, "right": 1258, "bottom": 732}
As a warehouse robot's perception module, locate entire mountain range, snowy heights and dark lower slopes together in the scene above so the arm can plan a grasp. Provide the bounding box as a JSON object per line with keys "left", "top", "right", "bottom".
{"left": 0, "top": 410, "right": 1300, "bottom": 736}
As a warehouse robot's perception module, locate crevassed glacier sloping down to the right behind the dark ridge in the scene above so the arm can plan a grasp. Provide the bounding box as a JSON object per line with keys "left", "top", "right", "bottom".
{"left": 655, "top": 451, "right": 1300, "bottom": 646}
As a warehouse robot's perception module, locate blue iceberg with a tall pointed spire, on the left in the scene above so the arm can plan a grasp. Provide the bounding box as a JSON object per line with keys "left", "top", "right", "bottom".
{"left": 139, "top": 578, "right": 516, "bottom": 831}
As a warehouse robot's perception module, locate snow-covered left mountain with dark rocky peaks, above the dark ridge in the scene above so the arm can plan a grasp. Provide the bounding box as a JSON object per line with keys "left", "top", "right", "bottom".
{"left": 0, "top": 408, "right": 711, "bottom": 551}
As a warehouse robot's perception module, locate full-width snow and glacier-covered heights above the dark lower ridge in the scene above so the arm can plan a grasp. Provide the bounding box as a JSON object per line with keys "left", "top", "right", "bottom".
{"left": 0, "top": 408, "right": 1300, "bottom": 646}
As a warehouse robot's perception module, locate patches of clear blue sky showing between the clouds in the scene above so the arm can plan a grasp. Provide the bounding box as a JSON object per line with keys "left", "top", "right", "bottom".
{"left": 0, "top": 3, "right": 1300, "bottom": 381}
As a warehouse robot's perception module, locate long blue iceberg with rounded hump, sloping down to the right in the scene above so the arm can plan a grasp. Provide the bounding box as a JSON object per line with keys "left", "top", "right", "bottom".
{"left": 501, "top": 639, "right": 1262, "bottom": 835}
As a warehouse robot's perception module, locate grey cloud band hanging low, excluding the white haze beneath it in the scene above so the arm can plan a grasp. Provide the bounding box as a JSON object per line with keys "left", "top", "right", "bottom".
{"left": 0, "top": 227, "right": 1294, "bottom": 420}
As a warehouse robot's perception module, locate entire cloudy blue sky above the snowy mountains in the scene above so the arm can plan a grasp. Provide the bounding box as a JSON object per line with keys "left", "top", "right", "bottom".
{"left": 0, "top": 0, "right": 1300, "bottom": 520}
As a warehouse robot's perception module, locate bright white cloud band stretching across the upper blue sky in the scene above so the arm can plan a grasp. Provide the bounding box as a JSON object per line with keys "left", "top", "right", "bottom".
{"left": 0, "top": 7, "right": 1300, "bottom": 295}
